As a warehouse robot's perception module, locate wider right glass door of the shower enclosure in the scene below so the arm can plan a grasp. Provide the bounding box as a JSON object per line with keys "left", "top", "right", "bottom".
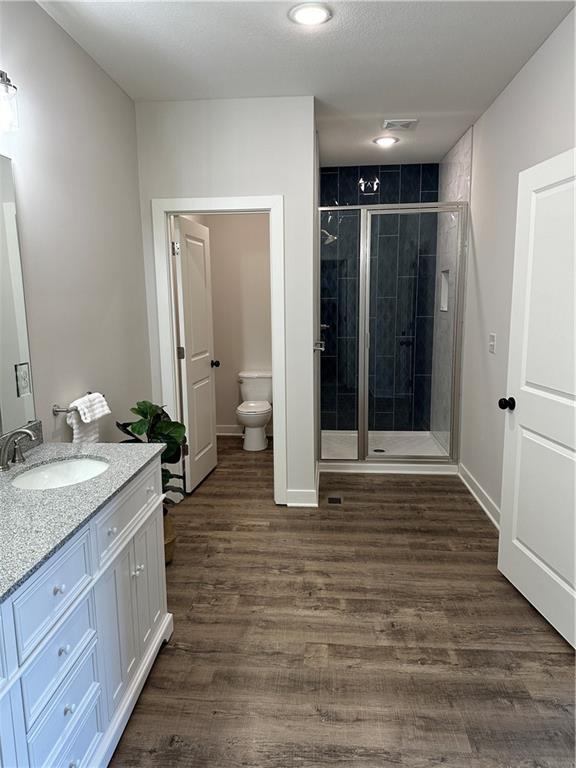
{"left": 366, "top": 209, "right": 460, "bottom": 459}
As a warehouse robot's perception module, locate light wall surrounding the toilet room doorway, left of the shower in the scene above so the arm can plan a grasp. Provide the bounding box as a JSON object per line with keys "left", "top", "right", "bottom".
{"left": 136, "top": 97, "right": 316, "bottom": 503}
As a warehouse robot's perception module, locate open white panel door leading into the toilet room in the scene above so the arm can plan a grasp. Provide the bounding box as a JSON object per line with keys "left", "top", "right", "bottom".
{"left": 175, "top": 216, "right": 218, "bottom": 493}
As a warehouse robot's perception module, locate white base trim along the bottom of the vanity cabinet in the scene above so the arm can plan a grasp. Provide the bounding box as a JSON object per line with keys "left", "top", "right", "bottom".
{"left": 90, "top": 613, "right": 173, "bottom": 768}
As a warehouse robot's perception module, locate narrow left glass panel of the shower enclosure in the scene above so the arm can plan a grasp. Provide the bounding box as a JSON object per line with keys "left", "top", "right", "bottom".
{"left": 320, "top": 209, "right": 360, "bottom": 460}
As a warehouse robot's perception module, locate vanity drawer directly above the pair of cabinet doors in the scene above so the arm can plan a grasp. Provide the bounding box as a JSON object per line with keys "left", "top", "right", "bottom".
{"left": 95, "top": 463, "right": 162, "bottom": 566}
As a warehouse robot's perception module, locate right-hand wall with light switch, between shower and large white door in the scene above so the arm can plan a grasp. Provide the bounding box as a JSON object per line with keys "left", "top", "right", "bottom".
{"left": 461, "top": 11, "right": 575, "bottom": 513}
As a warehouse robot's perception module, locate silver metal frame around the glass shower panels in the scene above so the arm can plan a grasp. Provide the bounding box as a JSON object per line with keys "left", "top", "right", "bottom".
{"left": 317, "top": 202, "right": 468, "bottom": 468}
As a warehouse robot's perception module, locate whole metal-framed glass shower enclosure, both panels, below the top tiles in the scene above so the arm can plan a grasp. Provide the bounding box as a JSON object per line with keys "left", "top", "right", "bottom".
{"left": 319, "top": 202, "right": 466, "bottom": 463}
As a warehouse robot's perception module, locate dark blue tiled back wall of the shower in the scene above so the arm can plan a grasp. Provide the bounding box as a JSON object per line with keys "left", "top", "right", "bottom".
{"left": 320, "top": 164, "right": 438, "bottom": 430}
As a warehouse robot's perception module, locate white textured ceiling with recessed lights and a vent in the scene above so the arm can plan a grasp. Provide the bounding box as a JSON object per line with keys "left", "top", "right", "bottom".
{"left": 42, "top": 0, "right": 573, "bottom": 165}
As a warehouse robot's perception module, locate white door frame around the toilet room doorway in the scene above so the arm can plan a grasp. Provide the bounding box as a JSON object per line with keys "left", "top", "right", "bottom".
{"left": 150, "top": 195, "right": 287, "bottom": 504}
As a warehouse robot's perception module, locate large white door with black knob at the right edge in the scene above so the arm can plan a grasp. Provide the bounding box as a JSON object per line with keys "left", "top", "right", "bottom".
{"left": 498, "top": 150, "right": 576, "bottom": 645}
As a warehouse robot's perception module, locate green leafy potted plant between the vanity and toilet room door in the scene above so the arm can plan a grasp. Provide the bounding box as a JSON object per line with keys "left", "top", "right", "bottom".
{"left": 116, "top": 400, "right": 186, "bottom": 563}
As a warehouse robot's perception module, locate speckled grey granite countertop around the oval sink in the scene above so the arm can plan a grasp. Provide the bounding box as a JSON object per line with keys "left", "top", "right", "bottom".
{"left": 0, "top": 443, "right": 164, "bottom": 602}
